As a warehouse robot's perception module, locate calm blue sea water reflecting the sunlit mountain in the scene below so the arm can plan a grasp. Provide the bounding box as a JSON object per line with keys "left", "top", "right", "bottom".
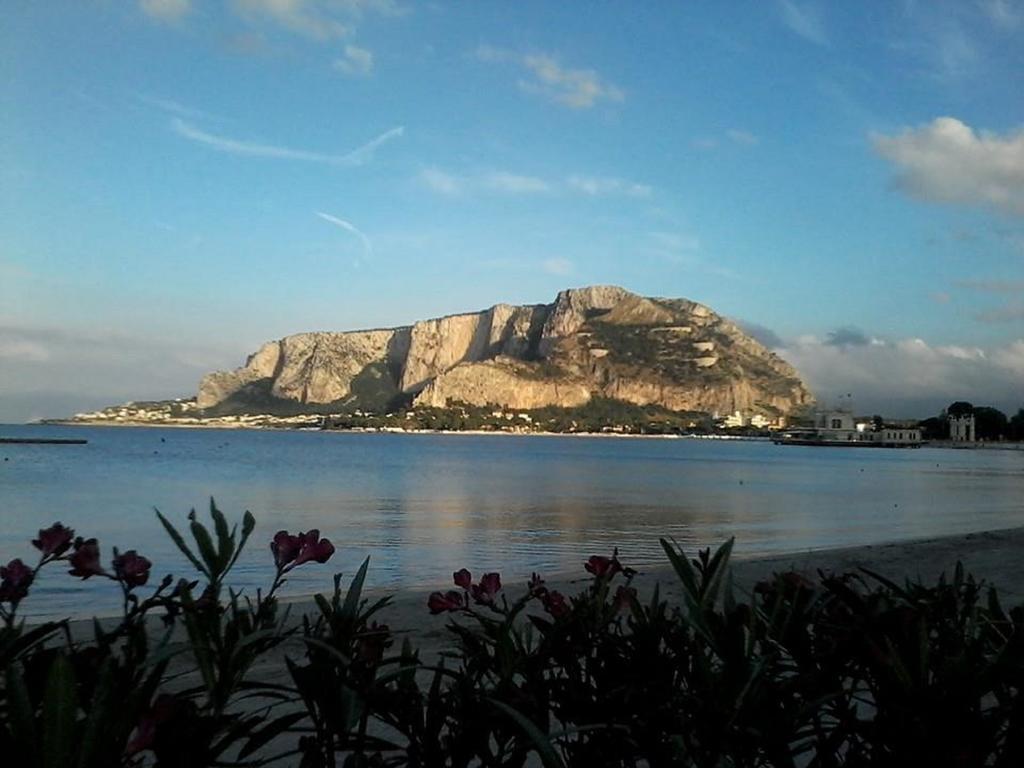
{"left": 0, "top": 426, "right": 1024, "bottom": 616}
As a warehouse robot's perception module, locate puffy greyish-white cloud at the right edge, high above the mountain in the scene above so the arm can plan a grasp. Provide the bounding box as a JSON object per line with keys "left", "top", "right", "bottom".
{"left": 872, "top": 117, "right": 1024, "bottom": 216}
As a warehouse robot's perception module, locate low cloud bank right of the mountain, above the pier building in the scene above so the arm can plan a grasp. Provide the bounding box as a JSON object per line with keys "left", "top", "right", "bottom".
{"left": 778, "top": 336, "right": 1024, "bottom": 417}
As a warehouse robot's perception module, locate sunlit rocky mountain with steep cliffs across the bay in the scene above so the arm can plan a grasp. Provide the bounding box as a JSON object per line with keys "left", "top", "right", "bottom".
{"left": 197, "top": 286, "right": 812, "bottom": 415}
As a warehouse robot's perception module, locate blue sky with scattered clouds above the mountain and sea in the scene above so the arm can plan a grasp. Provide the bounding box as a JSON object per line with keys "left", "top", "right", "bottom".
{"left": 0, "top": 0, "right": 1024, "bottom": 422}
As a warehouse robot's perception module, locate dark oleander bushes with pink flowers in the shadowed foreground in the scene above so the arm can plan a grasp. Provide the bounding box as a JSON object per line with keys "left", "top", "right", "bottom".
{"left": 0, "top": 503, "right": 1024, "bottom": 768}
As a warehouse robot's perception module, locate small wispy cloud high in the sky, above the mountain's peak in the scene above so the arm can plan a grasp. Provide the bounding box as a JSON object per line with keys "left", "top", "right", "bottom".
{"left": 476, "top": 45, "right": 626, "bottom": 110}
